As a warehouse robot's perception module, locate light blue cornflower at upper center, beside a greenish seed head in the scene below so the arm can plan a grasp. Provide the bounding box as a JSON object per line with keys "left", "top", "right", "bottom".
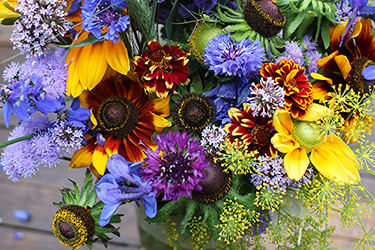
{"left": 203, "top": 34, "right": 265, "bottom": 77}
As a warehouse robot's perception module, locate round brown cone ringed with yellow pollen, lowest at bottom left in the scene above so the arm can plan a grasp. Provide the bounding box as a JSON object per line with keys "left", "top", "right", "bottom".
{"left": 52, "top": 205, "right": 95, "bottom": 248}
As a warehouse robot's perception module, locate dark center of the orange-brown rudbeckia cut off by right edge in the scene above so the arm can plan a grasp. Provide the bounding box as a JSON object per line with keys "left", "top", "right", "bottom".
{"left": 350, "top": 57, "right": 375, "bottom": 95}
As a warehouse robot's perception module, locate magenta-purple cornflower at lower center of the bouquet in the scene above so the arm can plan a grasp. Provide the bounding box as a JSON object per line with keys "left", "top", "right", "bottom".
{"left": 142, "top": 130, "right": 210, "bottom": 202}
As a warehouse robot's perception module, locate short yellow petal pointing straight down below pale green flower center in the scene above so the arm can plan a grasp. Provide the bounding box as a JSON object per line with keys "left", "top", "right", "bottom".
{"left": 284, "top": 148, "right": 310, "bottom": 181}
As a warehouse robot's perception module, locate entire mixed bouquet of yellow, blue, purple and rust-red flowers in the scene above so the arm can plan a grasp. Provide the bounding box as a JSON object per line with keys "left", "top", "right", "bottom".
{"left": 0, "top": 0, "right": 375, "bottom": 249}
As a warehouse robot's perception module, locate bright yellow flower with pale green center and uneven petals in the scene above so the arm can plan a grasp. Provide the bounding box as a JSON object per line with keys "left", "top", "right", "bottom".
{"left": 271, "top": 104, "right": 360, "bottom": 184}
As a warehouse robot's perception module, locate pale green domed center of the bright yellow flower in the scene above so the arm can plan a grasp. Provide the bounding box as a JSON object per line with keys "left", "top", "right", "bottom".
{"left": 292, "top": 120, "right": 323, "bottom": 153}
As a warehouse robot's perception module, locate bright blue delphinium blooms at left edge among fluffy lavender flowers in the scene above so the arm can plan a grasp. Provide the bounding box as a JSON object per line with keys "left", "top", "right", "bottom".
{"left": 2, "top": 76, "right": 61, "bottom": 127}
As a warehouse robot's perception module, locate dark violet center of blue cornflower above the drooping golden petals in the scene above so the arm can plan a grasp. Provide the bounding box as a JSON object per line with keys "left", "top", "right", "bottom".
{"left": 94, "top": 0, "right": 121, "bottom": 29}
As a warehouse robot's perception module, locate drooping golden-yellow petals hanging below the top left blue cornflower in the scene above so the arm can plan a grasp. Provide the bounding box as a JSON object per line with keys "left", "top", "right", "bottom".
{"left": 65, "top": 32, "right": 130, "bottom": 97}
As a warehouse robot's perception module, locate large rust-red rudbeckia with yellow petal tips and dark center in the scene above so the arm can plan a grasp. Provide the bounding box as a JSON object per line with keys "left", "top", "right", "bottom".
{"left": 70, "top": 72, "right": 171, "bottom": 175}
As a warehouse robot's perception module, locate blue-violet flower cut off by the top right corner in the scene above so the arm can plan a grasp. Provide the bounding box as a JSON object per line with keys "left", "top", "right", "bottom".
{"left": 339, "top": 0, "right": 375, "bottom": 46}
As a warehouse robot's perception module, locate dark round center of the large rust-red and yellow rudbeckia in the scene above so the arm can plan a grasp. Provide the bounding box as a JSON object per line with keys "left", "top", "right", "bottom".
{"left": 96, "top": 96, "right": 138, "bottom": 137}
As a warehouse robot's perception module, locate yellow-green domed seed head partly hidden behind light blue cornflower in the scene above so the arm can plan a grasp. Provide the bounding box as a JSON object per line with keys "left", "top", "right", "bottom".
{"left": 189, "top": 23, "right": 224, "bottom": 64}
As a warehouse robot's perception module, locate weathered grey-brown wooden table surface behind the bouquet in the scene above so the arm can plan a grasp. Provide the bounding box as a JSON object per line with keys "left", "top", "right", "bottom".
{"left": 0, "top": 27, "right": 375, "bottom": 250}
